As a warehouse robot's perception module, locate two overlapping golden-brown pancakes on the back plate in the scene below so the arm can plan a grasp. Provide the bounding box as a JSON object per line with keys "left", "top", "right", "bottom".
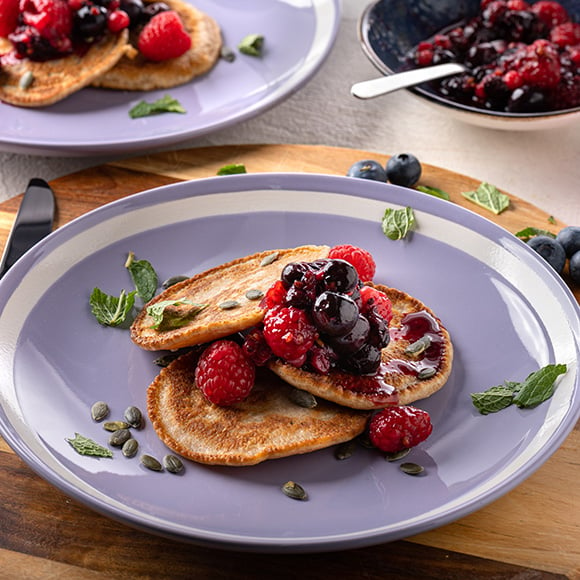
{"left": 0, "top": 0, "right": 222, "bottom": 107}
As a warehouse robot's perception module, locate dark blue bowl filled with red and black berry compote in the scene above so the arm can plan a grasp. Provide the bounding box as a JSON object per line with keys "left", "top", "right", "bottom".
{"left": 359, "top": 0, "right": 580, "bottom": 130}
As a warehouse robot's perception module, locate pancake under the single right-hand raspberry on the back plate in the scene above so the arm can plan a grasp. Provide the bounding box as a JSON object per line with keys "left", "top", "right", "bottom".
{"left": 93, "top": 0, "right": 222, "bottom": 91}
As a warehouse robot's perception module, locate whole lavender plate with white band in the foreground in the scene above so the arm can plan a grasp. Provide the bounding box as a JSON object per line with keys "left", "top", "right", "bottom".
{"left": 0, "top": 174, "right": 580, "bottom": 552}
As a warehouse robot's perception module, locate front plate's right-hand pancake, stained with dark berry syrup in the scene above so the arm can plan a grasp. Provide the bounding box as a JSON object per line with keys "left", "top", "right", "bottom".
{"left": 269, "top": 284, "right": 453, "bottom": 409}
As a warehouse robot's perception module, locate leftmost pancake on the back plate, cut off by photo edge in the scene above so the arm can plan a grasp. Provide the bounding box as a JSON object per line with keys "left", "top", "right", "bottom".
{"left": 0, "top": 30, "right": 130, "bottom": 107}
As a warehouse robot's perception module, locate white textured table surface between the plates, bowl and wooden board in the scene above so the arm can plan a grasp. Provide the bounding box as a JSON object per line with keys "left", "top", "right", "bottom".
{"left": 0, "top": 0, "right": 580, "bottom": 225}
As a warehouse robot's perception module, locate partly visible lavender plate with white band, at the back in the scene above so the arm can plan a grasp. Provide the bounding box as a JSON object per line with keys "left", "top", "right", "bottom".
{"left": 0, "top": 0, "right": 340, "bottom": 155}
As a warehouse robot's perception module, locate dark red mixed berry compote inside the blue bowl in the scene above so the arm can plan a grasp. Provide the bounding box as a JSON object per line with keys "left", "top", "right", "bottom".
{"left": 407, "top": 0, "right": 580, "bottom": 113}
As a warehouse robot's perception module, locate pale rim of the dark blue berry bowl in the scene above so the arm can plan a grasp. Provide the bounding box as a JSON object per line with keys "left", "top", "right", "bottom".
{"left": 357, "top": 0, "right": 580, "bottom": 121}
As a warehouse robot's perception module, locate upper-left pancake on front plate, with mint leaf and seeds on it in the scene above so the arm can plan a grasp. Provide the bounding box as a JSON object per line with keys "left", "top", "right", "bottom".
{"left": 131, "top": 246, "right": 330, "bottom": 350}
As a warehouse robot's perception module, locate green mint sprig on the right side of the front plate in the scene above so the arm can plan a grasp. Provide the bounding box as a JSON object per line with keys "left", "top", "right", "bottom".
{"left": 471, "top": 364, "right": 567, "bottom": 415}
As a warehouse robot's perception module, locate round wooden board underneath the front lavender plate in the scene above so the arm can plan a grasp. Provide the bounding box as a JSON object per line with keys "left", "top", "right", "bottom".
{"left": 0, "top": 145, "right": 580, "bottom": 579}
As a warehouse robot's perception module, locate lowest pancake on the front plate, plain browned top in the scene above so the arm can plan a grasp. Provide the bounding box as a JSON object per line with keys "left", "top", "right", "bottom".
{"left": 147, "top": 352, "right": 369, "bottom": 466}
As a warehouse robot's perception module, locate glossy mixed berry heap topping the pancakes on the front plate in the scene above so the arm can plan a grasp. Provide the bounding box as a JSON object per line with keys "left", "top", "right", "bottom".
{"left": 244, "top": 250, "right": 391, "bottom": 380}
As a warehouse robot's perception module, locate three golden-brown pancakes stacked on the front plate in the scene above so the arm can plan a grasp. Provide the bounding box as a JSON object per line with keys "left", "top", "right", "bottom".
{"left": 131, "top": 246, "right": 453, "bottom": 465}
